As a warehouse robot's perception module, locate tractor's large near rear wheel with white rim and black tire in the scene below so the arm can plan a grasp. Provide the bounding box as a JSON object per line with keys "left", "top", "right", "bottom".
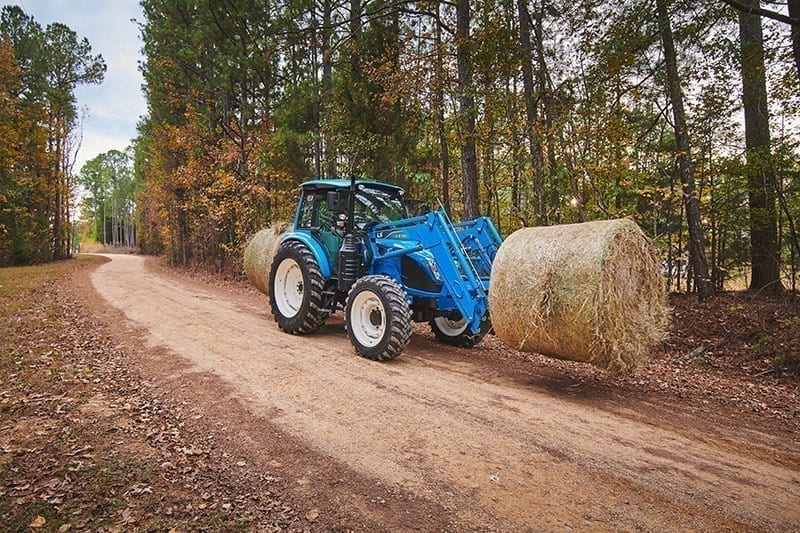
{"left": 269, "top": 241, "right": 330, "bottom": 334}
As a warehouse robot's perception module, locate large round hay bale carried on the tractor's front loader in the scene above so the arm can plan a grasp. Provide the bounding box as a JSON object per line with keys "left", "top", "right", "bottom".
{"left": 489, "top": 219, "right": 669, "bottom": 374}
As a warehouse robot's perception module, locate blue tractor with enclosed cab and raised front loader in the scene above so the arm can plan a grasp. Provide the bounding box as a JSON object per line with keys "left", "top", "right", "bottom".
{"left": 269, "top": 179, "right": 501, "bottom": 361}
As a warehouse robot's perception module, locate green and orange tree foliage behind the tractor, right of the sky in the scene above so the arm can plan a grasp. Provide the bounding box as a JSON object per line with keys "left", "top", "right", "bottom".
{"left": 137, "top": 0, "right": 800, "bottom": 289}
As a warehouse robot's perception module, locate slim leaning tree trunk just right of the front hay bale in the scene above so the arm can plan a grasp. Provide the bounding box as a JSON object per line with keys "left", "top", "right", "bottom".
{"left": 656, "top": 0, "right": 714, "bottom": 302}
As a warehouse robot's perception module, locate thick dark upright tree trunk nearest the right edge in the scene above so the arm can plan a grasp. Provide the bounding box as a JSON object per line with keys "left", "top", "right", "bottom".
{"left": 739, "top": 0, "right": 783, "bottom": 292}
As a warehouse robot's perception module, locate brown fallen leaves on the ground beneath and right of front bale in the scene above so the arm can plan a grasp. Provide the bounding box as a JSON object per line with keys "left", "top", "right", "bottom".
{"left": 462, "top": 293, "right": 800, "bottom": 424}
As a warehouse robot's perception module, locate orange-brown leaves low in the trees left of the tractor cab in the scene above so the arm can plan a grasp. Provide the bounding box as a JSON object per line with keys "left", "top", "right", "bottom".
{"left": 139, "top": 105, "right": 286, "bottom": 263}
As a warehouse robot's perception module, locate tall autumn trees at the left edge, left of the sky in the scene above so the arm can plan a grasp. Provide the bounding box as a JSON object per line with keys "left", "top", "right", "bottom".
{"left": 0, "top": 6, "right": 106, "bottom": 265}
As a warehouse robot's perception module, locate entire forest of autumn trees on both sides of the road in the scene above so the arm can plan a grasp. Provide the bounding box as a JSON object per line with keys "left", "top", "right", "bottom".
{"left": 0, "top": 0, "right": 800, "bottom": 299}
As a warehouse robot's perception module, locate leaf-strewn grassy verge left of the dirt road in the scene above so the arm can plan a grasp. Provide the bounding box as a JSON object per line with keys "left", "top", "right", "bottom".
{"left": 0, "top": 258, "right": 302, "bottom": 532}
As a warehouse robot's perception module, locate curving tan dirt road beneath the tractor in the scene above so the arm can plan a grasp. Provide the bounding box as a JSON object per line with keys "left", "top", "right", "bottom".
{"left": 92, "top": 255, "right": 800, "bottom": 531}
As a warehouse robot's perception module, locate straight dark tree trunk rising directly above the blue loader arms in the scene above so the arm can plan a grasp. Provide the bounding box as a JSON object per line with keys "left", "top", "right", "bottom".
{"left": 456, "top": 0, "right": 480, "bottom": 219}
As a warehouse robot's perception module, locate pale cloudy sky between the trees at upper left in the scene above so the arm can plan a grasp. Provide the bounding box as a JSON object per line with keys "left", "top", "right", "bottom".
{"left": 9, "top": 0, "right": 147, "bottom": 173}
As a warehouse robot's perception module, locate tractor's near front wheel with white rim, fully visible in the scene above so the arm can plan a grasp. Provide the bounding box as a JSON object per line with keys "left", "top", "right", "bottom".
{"left": 345, "top": 276, "right": 411, "bottom": 361}
